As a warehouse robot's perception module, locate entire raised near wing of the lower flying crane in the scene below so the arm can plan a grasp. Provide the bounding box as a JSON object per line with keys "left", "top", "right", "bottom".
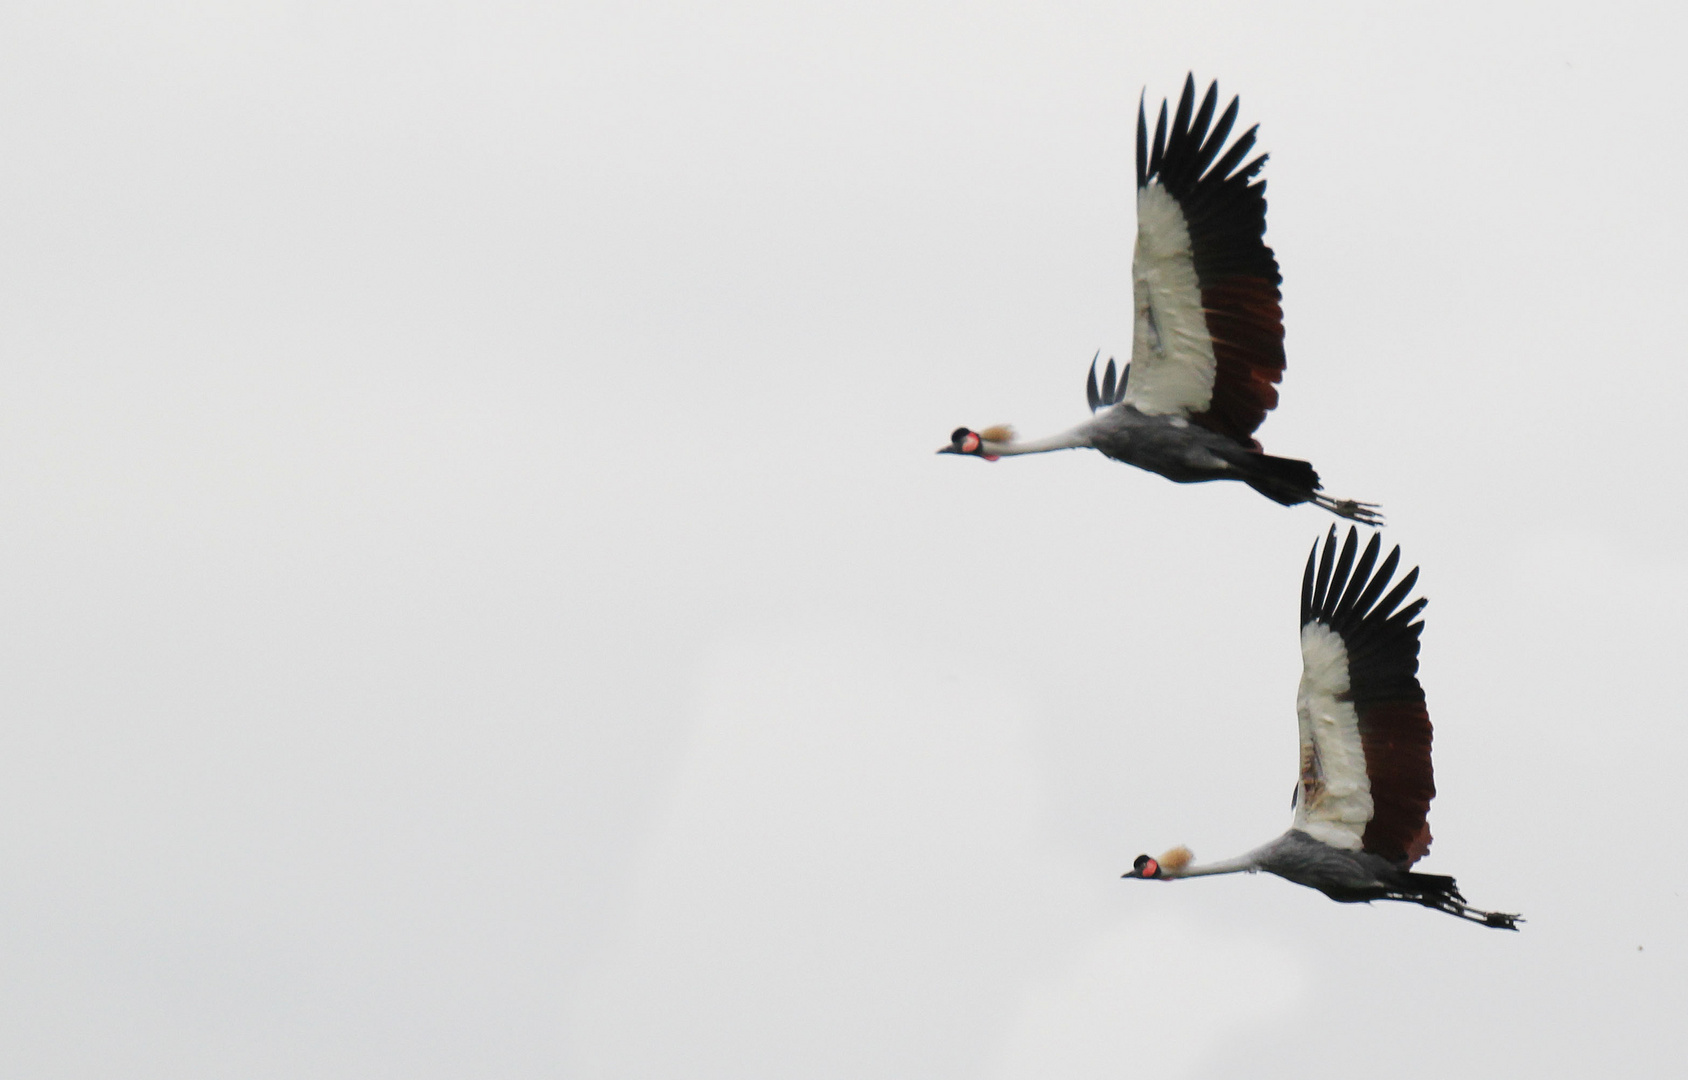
{"left": 1295, "top": 527, "right": 1436, "bottom": 867}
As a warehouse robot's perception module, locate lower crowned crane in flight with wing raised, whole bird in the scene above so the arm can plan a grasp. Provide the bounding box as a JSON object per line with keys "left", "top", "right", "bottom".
{"left": 1126, "top": 527, "right": 1523, "bottom": 930}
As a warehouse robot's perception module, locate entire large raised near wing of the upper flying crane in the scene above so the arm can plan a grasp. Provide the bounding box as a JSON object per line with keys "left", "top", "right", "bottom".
{"left": 1126, "top": 78, "right": 1285, "bottom": 449}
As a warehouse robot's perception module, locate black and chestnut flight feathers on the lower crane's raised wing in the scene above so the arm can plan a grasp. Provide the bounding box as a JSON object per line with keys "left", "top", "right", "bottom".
{"left": 1301, "top": 527, "right": 1436, "bottom": 867}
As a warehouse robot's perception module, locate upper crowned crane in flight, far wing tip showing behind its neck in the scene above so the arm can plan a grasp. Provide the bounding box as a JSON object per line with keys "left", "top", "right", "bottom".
{"left": 939, "top": 76, "right": 1381, "bottom": 525}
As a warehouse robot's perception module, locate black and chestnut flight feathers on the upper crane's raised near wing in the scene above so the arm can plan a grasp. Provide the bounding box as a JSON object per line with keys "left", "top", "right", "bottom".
{"left": 1136, "top": 74, "right": 1285, "bottom": 449}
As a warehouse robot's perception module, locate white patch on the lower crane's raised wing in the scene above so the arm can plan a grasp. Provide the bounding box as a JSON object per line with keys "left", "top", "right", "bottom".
{"left": 1295, "top": 623, "right": 1372, "bottom": 851}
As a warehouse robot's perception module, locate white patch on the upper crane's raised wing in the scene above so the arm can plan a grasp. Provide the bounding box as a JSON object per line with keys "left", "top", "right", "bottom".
{"left": 1126, "top": 181, "right": 1219, "bottom": 415}
